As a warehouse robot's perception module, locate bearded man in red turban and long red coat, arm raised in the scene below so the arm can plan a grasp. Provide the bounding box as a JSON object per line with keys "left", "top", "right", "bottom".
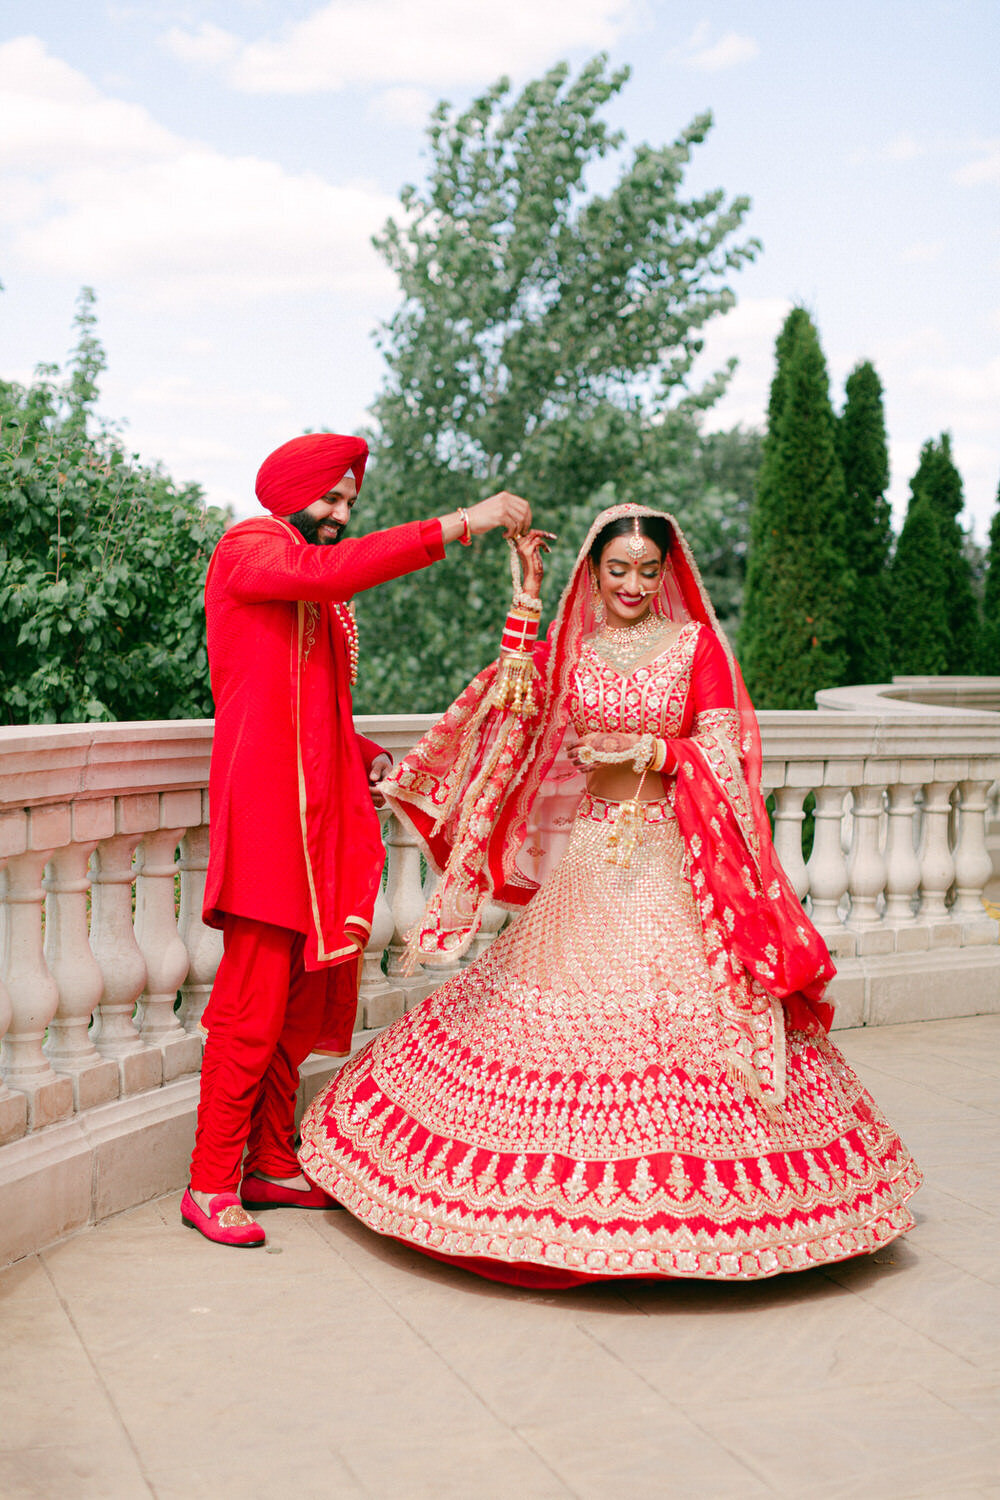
{"left": 181, "top": 432, "right": 531, "bottom": 1247}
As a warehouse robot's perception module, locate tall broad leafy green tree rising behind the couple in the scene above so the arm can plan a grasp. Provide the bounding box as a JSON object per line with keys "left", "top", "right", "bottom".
{"left": 357, "top": 57, "right": 756, "bottom": 711}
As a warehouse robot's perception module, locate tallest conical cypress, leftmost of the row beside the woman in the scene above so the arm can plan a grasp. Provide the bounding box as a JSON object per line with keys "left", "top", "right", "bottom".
{"left": 741, "top": 308, "right": 850, "bottom": 708}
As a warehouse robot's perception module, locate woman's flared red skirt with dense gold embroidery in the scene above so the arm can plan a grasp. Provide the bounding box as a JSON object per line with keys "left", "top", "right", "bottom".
{"left": 300, "top": 797, "right": 921, "bottom": 1287}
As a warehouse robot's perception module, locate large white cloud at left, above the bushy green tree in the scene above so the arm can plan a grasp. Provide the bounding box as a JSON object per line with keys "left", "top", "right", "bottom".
{"left": 0, "top": 38, "right": 397, "bottom": 305}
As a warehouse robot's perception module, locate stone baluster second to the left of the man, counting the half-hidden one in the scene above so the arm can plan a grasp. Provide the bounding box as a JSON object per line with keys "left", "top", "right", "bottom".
{"left": 135, "top": 810, "right": 201, "bottom": 1083}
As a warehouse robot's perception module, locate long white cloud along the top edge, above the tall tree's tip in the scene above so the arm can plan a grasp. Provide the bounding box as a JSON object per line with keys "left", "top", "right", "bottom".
{"left": 160, "top": 0, "right": 634, "bottom": 95}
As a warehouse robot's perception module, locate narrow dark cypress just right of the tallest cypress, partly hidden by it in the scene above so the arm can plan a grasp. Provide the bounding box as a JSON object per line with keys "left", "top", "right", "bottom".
{"left": 837, "top": 360, "right": 892, "bottom": 683}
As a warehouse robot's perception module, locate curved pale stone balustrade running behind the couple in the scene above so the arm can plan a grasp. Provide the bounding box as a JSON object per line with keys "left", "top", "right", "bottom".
{"left": 0, "top": 680, "right": 1000, "bottom": 1263}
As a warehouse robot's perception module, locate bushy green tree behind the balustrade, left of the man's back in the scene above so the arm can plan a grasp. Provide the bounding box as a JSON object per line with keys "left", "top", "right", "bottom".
{"left": 0, "top": 290, "right": 228, "bottom": 723}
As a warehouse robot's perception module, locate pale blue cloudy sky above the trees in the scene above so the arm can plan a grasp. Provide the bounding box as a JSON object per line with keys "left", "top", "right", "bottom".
{"left": 0, "top": 0, "right": 1000, "bottom": 537}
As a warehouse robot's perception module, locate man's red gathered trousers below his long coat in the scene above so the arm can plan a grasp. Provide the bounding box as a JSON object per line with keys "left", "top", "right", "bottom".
{"left": 190, "top": 917, "right": 330, "bottom": 1193}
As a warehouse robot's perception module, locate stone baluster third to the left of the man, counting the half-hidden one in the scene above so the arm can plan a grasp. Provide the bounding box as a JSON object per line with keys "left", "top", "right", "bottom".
{"left": 90, "top": 822, "right": 163, "bottom": 1094}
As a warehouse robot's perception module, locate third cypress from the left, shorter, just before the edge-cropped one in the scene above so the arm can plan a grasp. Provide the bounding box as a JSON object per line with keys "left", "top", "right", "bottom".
{"left": 891, "top": 432, "right": 979, "bottom": 675}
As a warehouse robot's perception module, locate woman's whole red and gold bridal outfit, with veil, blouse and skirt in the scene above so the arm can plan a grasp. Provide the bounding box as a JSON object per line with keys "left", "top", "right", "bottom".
{"left": 300, "top": 506, "right": 921, "bottom": 1287}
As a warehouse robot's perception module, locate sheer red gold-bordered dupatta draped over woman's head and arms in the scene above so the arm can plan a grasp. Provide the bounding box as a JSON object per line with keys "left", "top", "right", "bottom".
{"left": 384, "top": 504, "right": 835, "bottom": 1031}
